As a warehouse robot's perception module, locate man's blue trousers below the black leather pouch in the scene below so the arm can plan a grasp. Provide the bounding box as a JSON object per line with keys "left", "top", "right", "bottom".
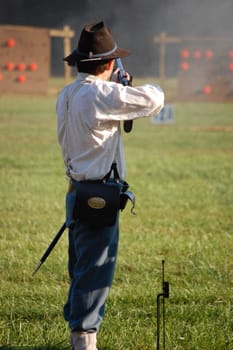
{"left": 64, "top": 218, "right": 119, "bottom": 332}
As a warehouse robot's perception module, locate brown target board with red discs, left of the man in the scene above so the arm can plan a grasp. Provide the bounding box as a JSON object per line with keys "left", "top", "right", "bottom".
{"left": 0, "top": 26, "right": 50, "bottom": 93}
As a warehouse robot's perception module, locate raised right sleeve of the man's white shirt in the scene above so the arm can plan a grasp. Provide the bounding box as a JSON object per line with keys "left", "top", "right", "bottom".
{"left": 96, "top": 83, "right": 164, "bottom": 121}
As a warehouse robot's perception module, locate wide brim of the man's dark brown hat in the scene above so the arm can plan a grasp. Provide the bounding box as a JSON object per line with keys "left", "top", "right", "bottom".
{"left": 63, "top": 47, "right": 131, "bottom": 65}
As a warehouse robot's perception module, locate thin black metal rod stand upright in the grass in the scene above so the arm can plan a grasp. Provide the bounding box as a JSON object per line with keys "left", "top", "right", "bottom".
{"left": 157, "top": 260, "right": 169, "bottom": 350}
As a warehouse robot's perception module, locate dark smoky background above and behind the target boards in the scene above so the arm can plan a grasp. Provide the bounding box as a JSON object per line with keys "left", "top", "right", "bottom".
{"left": 0, "top": 0, "right": 233, "bottom": 76}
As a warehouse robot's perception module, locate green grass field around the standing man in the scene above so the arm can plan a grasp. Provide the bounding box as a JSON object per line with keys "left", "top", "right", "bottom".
{"left": 0, "top": 80, "right": 233, "bottom": 350}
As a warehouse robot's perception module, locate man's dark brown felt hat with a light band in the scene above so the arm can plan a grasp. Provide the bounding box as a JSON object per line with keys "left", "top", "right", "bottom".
{"left": 64, "top": 22, "right": 130, "bottom": 66}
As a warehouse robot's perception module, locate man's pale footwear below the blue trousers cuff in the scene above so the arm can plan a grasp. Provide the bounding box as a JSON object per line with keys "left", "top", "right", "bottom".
{"left": 70, "top": 331, "right": 97, "bottom": 350}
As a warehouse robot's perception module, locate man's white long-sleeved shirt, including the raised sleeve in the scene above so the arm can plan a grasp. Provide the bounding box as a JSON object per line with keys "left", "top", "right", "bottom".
{"left": 56, "top": 73, "right": 164, "bottom": 181}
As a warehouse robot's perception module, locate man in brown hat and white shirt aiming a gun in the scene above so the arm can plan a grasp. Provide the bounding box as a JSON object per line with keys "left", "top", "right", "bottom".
{"left": 57, "top": 22, "right": 164, "bottom": 350}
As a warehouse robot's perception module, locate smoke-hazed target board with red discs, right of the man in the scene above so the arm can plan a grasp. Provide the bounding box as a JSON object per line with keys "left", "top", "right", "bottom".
{"left": 179, "top": 39, "right": 233, "bottom": 102}
